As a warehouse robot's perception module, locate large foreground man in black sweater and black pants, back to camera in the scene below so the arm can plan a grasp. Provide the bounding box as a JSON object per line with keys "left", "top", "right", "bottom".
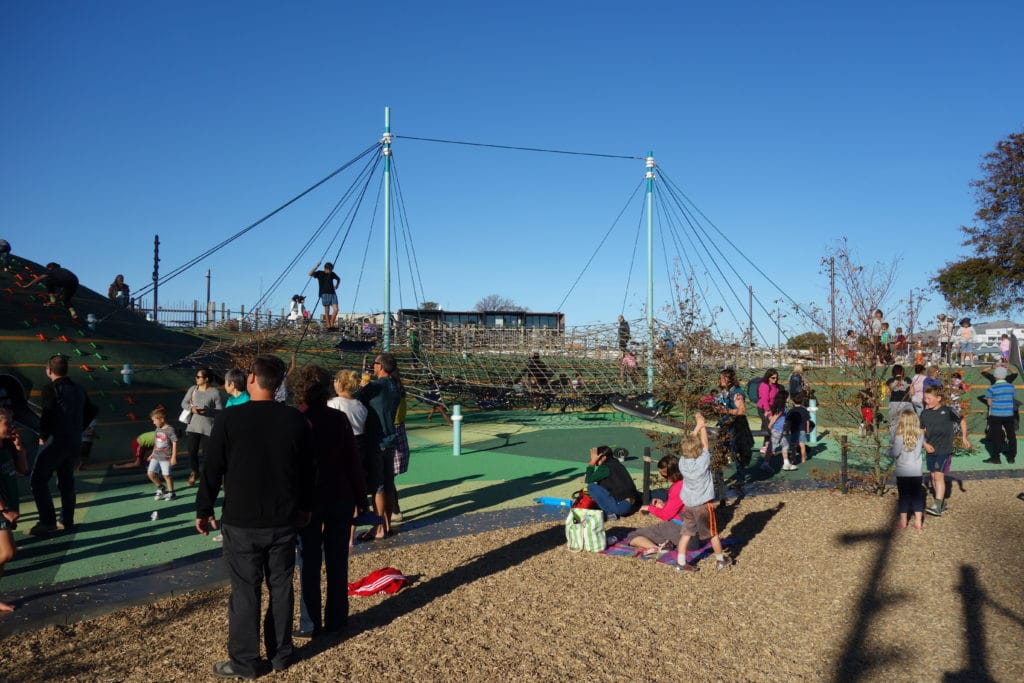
{"left": 196, "top": 355, "right": 314, "bottom": 679}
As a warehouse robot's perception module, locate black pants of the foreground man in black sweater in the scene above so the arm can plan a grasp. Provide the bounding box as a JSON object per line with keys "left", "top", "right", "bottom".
{"left": 222, "top": 524, "right": 296, "bottom": 676}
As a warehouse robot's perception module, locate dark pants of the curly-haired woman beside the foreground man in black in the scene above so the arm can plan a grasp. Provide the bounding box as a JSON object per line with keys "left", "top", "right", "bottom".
{"left": 298, "top": 500, "right": 355, "bottom": 633}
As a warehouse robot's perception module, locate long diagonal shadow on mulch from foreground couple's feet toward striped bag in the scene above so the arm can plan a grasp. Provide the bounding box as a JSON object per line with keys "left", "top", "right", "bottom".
{"left": 296, "top": 525, "right": 565, "bottom": 660}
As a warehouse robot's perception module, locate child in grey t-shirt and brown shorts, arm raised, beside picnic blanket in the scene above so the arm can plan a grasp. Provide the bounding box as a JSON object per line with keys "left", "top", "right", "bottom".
{"left": 676, "top": 413, "right": 732, "bottom": 572}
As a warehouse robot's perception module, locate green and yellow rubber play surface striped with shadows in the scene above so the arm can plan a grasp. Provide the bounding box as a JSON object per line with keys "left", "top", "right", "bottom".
{"left": 8, "top": 411, "right": 1019, "bottom": 594}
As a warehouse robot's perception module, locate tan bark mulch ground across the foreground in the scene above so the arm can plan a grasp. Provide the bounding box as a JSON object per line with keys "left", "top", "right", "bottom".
{"left": 0, "top": 480, "right": 1024, "bottom": 682}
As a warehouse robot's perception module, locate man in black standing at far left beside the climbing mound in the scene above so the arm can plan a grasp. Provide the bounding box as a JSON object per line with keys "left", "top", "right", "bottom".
{"left": 29, "top": 353, "right": 96, "bottom": 536}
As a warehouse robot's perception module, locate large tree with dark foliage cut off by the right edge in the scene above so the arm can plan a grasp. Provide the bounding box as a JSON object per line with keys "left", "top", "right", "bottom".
{"left": 932, "top": 132, "right": 1024, "bottom": 313}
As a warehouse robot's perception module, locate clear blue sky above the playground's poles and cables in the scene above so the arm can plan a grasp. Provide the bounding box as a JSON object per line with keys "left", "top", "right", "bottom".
{"left": 0, "top": 0, "right": 1024, "bottom": 342}
